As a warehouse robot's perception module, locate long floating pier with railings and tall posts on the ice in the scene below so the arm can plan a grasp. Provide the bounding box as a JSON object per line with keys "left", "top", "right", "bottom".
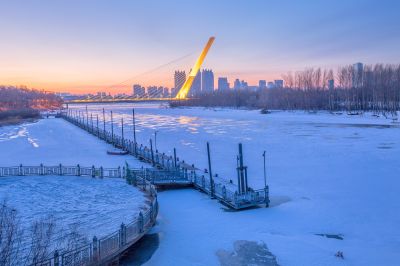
{"left": 61, "top": 110, "right": 269, "bottom": 210}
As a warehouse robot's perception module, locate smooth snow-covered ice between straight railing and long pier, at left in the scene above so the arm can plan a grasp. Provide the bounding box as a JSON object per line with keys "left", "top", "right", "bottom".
{"left": 0, "top": 118, "right": 143, "bottom": 167}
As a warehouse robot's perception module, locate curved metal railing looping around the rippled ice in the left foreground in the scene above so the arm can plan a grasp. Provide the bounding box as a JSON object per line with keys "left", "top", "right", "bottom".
{"left": 0, "top": 164, "right": 158, "bottom": 266}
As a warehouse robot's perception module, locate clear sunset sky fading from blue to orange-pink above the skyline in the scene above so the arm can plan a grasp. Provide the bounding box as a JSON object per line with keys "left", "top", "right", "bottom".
{"left": 0, "top": 0, "right": 400, "bottom": 93}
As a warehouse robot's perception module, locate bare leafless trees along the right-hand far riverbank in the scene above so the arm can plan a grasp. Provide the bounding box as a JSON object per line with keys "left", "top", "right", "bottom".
{"left": 171, "top": 64, "right": 400, "bottom": 113}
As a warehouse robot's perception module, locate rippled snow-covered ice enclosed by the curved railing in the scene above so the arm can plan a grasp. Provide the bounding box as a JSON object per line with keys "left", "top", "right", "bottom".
{"left": 0, "top": 176, "right": 145, "bottom": 243}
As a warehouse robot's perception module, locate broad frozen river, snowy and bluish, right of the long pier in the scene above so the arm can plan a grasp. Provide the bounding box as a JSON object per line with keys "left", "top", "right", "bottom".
{"left": 70, "top": 104, "right": 400, "bottom": 265}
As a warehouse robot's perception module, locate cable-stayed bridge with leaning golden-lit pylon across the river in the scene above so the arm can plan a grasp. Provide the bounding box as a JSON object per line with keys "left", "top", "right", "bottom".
{"left": 65, "top": 37, "right": 215, "bottom": 103}
